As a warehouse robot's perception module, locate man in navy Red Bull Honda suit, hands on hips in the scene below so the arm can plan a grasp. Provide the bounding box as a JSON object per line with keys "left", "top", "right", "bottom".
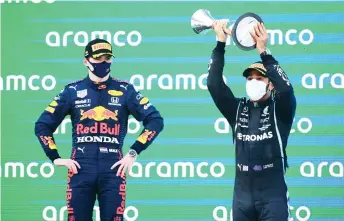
{"left": 35, "top": 39, "right": 164, "bottom": 221}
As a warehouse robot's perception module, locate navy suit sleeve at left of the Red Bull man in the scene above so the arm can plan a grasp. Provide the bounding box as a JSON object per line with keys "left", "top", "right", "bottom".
{"left": 35, "top": 87, "right": 71, "bottom": 162}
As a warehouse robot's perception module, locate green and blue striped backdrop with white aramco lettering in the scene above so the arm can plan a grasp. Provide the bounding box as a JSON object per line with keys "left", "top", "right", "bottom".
{"left": 0, "top": 1, "right": 344, "bottom": 221}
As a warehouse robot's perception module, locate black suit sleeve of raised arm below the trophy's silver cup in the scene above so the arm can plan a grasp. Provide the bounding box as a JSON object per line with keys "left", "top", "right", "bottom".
{"left": 207, "top": 41, "right": 239, "bottom": 126}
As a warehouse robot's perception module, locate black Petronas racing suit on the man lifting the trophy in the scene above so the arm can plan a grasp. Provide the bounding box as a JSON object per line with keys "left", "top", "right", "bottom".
{"left": 207, "top": 42, "right": 296, "bottom": 221}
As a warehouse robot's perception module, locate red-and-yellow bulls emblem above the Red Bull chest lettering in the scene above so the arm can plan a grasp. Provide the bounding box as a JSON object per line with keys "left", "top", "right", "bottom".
{"left": 80, "top": 106, "right": 118, "bottom": 121}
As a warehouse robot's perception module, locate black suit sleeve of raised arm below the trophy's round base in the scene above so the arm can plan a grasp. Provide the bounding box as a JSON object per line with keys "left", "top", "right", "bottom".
{"left": 261, "top": 55, "right": 296, "bottom": 125}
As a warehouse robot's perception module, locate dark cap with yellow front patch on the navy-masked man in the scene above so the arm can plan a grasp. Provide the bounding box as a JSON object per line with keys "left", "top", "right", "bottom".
{"left": 84, "top": 38, "right": 115, "bottom": 58}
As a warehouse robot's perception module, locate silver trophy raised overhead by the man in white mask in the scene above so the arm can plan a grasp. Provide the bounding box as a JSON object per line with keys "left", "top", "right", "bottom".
{"left": 191, "top": 9, "right": 263, "bottom": 51}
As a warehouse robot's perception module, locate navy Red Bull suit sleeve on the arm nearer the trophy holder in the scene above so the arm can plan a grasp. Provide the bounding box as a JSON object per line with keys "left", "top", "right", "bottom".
{"left": 128, "top": 84, "right": 164, "bottom": 154}
